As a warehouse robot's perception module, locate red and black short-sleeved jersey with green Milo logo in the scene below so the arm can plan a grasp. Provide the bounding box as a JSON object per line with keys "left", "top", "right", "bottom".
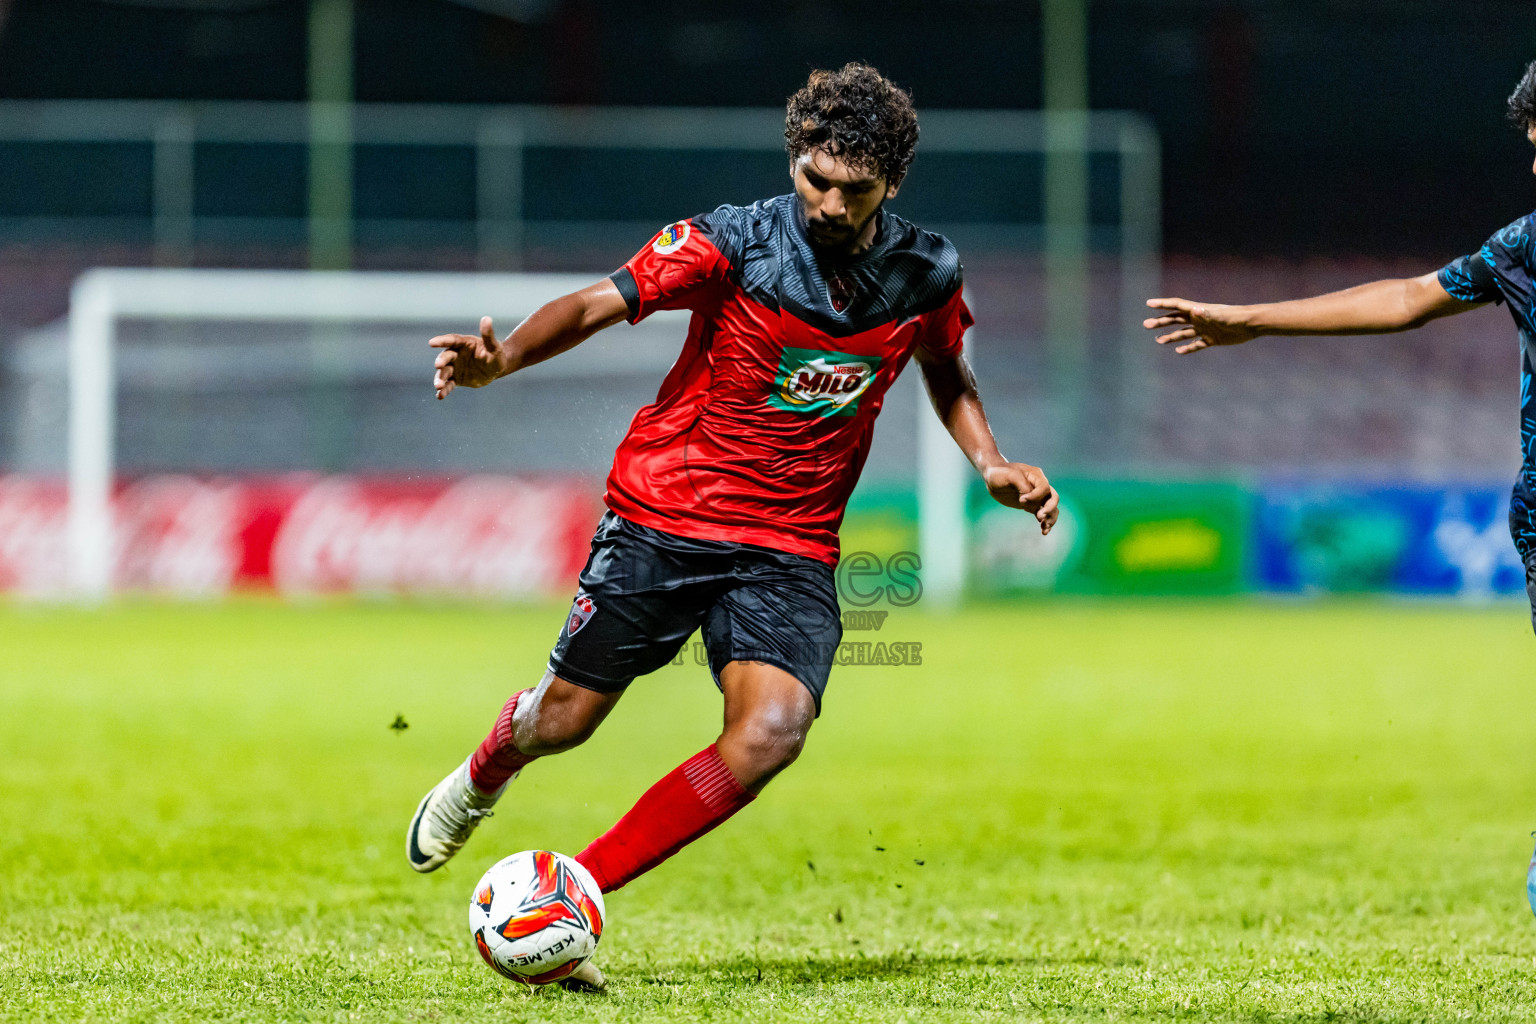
{"left": 605, "top": 195, "right": 972, "bottom": 563}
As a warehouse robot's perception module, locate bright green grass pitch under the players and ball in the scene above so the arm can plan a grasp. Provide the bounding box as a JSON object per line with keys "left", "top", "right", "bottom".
{"left": 0, "top": 602, "right": 1536, "bottom": 1024}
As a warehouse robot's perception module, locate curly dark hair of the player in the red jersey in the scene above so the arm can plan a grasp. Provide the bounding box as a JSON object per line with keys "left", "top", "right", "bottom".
{"left": 783, "top": 63, "right": 917, "bottom": 184}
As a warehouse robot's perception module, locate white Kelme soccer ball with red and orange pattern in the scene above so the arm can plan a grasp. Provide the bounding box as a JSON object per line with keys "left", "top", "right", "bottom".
{"left": 470, "top": 851, "right": 605, "bottom": 986}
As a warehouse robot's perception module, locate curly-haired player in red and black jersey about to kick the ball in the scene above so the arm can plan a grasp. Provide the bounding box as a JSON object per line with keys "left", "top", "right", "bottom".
{"left": 407, "top": 64, "right": 1057, "bottom": 982}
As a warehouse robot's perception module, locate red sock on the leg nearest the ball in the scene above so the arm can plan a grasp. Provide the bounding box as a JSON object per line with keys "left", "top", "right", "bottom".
{"left": 576, "top": 743, "right": 753, "bottom": 892}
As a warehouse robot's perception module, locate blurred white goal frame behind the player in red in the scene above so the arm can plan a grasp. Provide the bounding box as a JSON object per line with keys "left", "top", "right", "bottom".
{"left": 66, "top": 269, "right": 968, "bottom": 603}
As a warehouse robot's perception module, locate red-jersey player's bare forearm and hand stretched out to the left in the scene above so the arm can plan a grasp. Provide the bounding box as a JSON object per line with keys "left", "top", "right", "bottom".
{"left": 427, "top": 278, "right": 630, "bottom": 399}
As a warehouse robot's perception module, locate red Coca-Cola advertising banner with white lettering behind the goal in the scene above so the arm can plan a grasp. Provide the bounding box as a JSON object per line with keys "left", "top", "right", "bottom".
{"left": 0, "top": 476, "right": 602, "bottom": 599}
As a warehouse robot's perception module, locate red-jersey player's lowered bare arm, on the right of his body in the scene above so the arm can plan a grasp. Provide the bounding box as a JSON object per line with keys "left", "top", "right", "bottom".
{"left": 914, "top": 347, "right": 1057, "bottom": 533}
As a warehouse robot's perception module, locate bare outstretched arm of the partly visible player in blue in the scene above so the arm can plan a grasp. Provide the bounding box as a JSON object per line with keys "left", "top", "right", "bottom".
{"left": 1141, "top": 273, "right": 1481, "bottom": 355}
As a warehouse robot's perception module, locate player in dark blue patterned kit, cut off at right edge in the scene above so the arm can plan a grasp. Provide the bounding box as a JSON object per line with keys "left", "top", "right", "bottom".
{"left": 1143, "top": 61, "right": 1536, "bottom": 632}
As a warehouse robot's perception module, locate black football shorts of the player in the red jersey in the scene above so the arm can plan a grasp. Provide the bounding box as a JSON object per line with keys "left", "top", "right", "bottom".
{"left": 550, "top": 511, "right": 843, "bottom": 714}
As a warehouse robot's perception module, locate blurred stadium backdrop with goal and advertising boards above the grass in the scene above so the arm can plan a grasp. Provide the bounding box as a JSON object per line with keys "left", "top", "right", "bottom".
{"left": 0, "top": 0, "right": 1536, "bottom": 599}
